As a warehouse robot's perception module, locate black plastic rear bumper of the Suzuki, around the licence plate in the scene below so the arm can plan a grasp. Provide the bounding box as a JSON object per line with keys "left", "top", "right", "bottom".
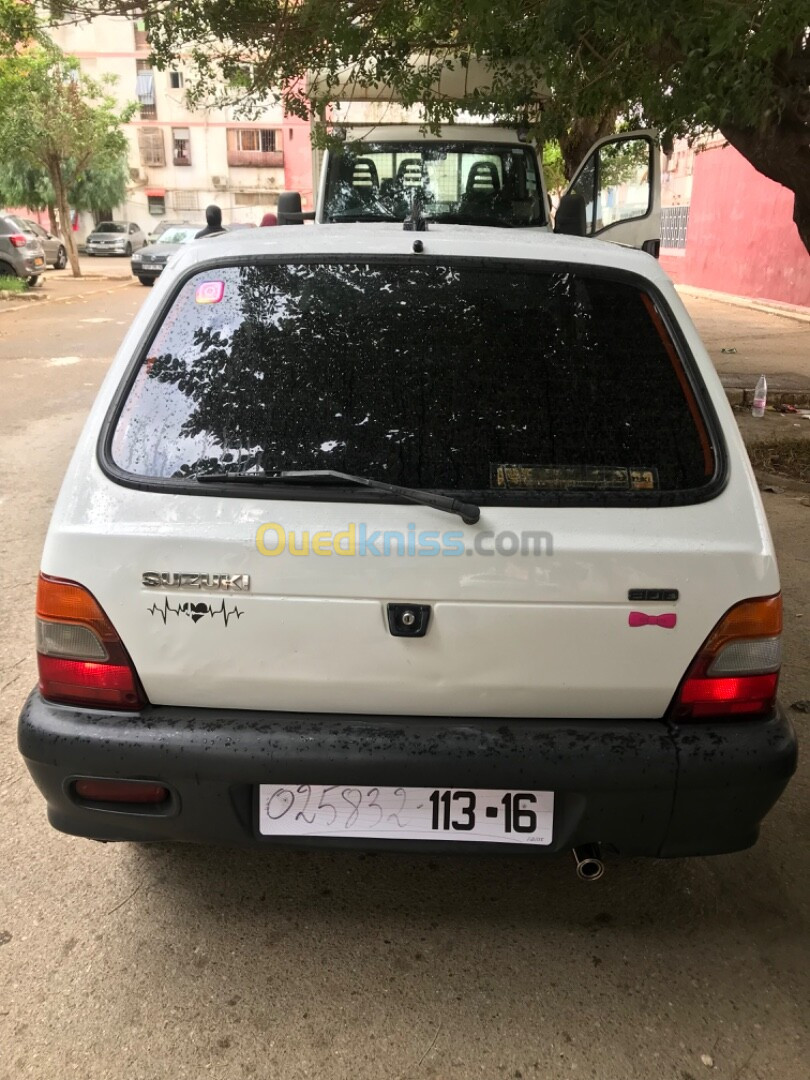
{"left": 18, "top": 691, "right": 797, "bottom": 856}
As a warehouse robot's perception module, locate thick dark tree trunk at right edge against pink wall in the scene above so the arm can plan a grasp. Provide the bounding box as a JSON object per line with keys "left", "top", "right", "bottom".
{"left": 720, "top": 120, "right": 810, "bottom": 255}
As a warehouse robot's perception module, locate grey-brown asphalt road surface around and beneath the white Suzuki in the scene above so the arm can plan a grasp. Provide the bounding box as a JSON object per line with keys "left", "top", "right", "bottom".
{"left": 0, "top": 284, "right": 810, "bottom": 1080}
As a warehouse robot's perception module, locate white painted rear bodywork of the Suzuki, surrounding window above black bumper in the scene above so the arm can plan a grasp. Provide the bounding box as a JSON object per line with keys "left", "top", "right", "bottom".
{"left": 42, "top": 225, "right": 780, "bottom": 718}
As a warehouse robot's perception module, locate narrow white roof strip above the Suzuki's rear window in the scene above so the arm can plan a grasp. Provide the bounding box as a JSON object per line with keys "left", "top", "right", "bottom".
{"left": 174, "top": 222, "right": 669, "bottom": 283}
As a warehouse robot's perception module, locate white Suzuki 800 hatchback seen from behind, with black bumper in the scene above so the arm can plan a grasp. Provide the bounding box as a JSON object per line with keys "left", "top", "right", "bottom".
{"left": 19, "top": 225, "right": 796, "bottom": 877}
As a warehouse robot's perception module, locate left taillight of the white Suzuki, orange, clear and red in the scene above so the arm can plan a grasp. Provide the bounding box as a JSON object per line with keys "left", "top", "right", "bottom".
{"left": 37, "top": 573, "right": 146, "bottom": 712}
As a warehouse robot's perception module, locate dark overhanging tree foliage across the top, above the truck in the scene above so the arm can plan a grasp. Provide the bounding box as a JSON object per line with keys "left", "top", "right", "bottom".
{"left": 22, "top": 0, "right": 810, "bottom": 247}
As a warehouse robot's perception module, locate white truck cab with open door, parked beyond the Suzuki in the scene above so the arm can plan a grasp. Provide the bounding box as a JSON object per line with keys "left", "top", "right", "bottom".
{"left": 279, "top": 124, "right": 661, "bottom": 255}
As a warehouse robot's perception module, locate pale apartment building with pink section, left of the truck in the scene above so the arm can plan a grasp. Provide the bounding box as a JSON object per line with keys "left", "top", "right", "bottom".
{"left": 53, "top": 17, "right": 312, "bottom": 235}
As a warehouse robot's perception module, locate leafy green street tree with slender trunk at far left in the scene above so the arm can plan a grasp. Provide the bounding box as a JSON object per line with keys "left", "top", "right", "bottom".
{"left": 0, "top": 44, "right": 134, "bottom": 276}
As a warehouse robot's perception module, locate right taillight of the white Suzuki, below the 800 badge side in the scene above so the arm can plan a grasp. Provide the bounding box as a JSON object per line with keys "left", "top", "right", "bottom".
{"left": 674, "top": 594, "right": 782, "bottom": 719}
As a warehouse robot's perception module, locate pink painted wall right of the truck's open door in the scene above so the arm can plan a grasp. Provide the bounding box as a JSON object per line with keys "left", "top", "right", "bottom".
{"left": 661, "top": 146, "right": 810, "bottom": 307}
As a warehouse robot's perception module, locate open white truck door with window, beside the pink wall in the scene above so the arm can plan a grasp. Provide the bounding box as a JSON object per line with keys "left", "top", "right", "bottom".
{"left": 556, "top": 131, "right": 661, "bottom": 256}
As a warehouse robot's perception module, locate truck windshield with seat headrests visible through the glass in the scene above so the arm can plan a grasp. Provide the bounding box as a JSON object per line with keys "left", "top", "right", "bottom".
{"left": 324, "top": 141, "right": 548, "bottom": 228}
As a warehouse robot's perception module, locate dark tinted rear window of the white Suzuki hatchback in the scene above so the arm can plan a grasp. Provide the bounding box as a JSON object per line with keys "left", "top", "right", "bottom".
{"left": 111, "top": 256, "right": 715, "bottom": 502}
